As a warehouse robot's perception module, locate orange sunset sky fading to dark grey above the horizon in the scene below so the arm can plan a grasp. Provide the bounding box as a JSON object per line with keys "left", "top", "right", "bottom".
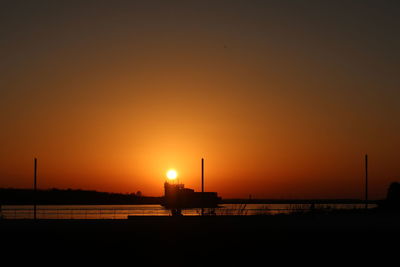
{"left": 0, "top": 0, "right": 400, "bottom": 199}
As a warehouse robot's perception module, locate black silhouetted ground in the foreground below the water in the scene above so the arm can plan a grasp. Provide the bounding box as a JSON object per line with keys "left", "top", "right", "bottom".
{"left": 0, "top": 213, "right": 400, "bottom": 266}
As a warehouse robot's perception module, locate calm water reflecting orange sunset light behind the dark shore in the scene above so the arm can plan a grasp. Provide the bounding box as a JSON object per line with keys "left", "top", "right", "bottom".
{"left": 1, "top": 204, "right": 376, "bottom": 219}
